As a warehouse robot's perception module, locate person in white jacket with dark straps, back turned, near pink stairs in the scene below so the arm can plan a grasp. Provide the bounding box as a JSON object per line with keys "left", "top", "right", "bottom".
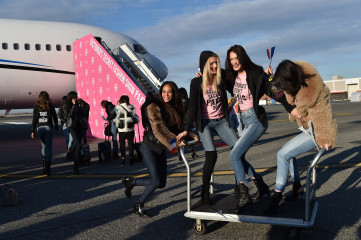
{"left": 114, "top": 95, "right": 139, "bottom": 165}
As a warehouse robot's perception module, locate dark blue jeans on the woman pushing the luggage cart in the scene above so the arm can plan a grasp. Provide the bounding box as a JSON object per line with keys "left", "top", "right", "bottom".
{"left": 134, "top": 143, "right": 167, "bottom": 203}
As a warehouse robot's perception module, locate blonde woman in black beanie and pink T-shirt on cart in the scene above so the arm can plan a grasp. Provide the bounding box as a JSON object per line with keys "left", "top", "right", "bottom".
{"left": 177, "top": 51, "right": 262, "bottom": 205}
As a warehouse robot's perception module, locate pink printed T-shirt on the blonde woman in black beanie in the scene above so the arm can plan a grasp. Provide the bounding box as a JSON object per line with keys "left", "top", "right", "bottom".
{"left": 202, "top": 86, "right": 224, "bottom": 119}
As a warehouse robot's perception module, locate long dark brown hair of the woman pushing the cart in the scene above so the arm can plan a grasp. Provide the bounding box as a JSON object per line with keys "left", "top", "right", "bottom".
{"left": 159, "top": 81, "right": 185, "bottom": 129}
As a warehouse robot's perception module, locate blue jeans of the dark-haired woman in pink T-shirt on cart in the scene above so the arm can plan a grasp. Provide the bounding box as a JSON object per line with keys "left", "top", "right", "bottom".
{"left": 229, "top": 108, "right": 267, "bottom": 186}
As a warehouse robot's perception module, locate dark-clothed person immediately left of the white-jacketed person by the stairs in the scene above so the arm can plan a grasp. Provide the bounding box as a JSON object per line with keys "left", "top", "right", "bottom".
{"left": 101, "top": 100, "right": 119, "bottom": 160}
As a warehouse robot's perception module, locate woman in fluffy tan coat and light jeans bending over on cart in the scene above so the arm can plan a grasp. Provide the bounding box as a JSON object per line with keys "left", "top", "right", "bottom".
{"left": 264, "top": 60, "right": 337, "bottom": 215}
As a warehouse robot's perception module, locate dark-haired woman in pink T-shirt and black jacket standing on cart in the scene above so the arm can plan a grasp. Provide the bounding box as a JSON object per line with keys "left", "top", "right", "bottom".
{"left": 226, "top": 45, "right": 294, "bottom": 213}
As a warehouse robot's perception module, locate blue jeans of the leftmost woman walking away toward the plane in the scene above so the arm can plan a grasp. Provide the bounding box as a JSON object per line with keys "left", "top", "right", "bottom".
{"left": 38, "top": 126, "right": 54, "bottom": 163}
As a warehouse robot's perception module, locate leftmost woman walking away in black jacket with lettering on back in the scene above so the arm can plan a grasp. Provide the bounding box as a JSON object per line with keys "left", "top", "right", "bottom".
{"left": 31, "top": 91, "right": 58, "bottom": 176}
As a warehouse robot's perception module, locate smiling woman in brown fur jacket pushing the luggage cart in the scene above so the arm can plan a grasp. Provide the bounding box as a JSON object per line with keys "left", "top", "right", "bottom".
{"left": 123, "top": 81, "right": 198, "bottom": 217}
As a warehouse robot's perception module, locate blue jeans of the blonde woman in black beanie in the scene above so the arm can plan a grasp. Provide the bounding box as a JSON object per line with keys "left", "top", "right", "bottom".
{"left": 198, "top": 118, "right": 238, "bottom": 151}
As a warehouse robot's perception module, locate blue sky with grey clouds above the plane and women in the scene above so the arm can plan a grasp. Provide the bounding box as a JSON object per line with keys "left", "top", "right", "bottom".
{"left": 0, "top": 0, "right": 361, "bottom": 90}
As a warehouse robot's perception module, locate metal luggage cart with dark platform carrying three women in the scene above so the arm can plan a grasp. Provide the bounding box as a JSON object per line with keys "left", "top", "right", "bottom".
{"left": 180, "top": 143, "right": 325, "bottom": 235}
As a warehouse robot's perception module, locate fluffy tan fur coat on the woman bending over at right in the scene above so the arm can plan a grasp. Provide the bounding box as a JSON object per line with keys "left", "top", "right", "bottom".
{"left": 285, "top": 61, "right": 337, "bottom": 147}
